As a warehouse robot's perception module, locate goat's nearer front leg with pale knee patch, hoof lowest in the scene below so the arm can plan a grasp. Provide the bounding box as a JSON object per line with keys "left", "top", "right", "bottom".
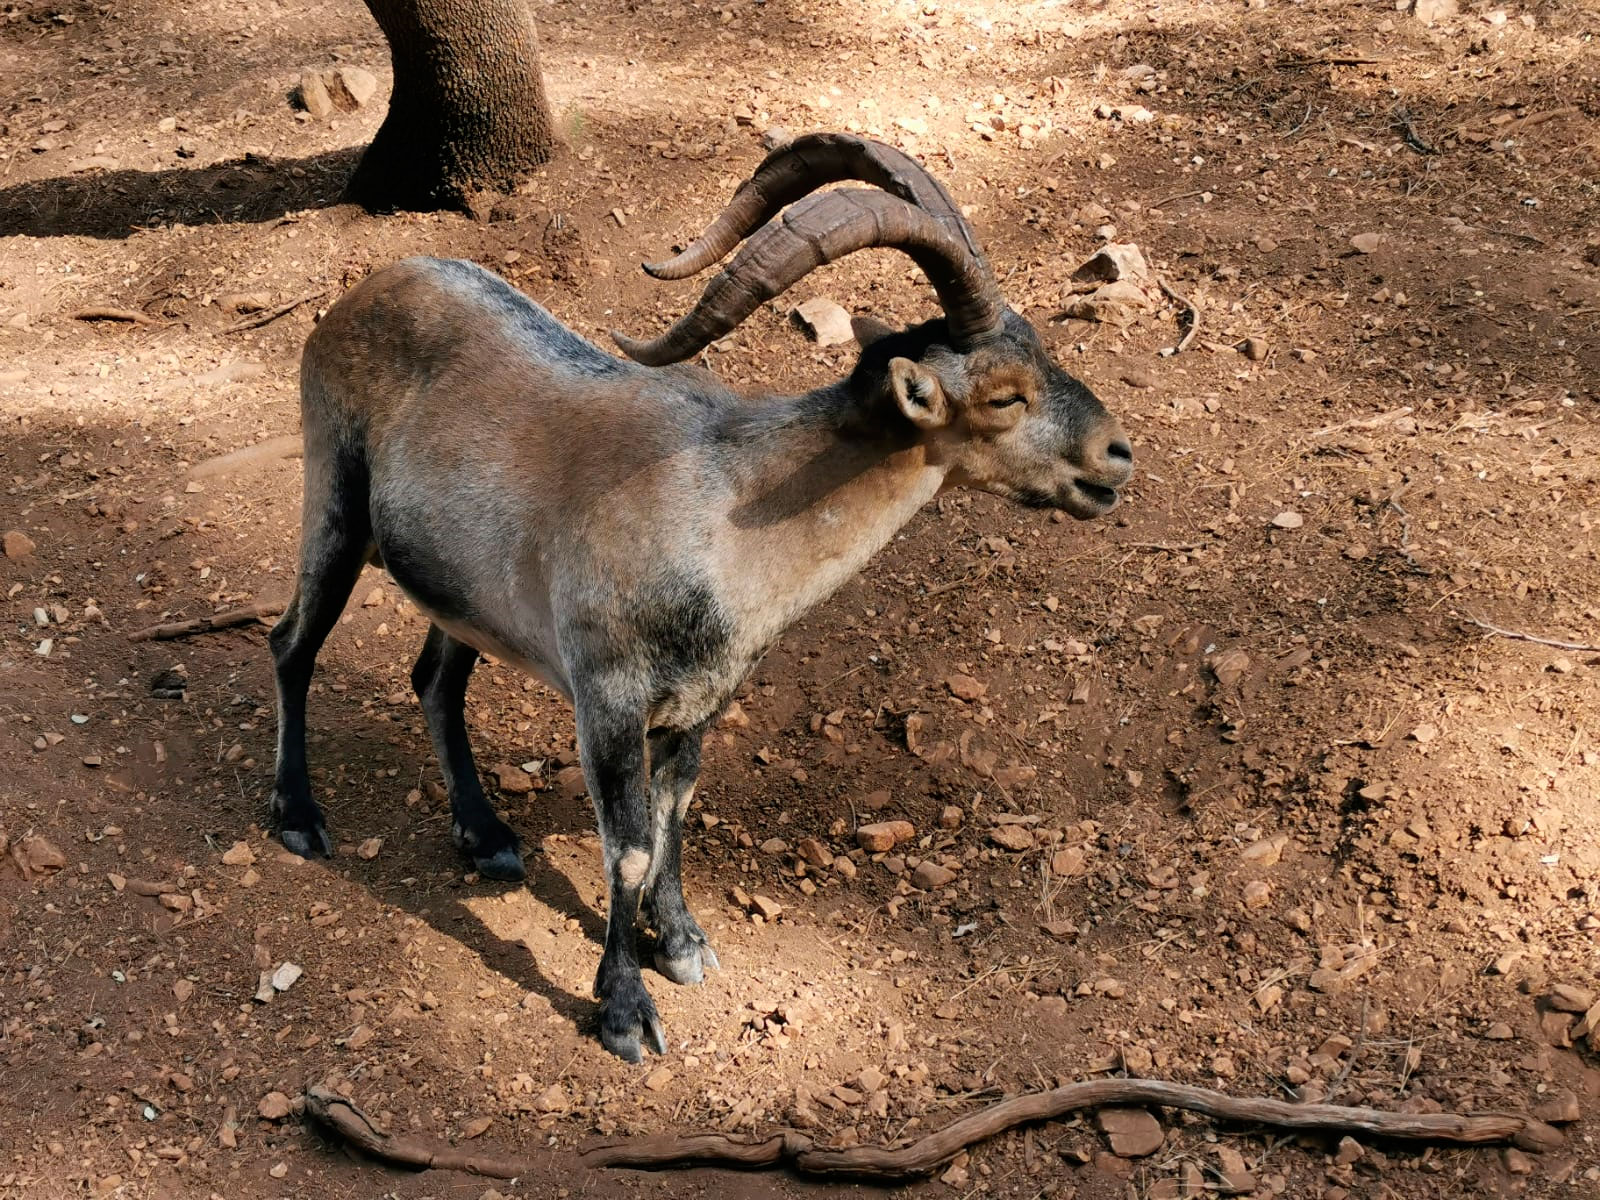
{"left": 576, "top": 694, "right": 667, "bottom": 1062}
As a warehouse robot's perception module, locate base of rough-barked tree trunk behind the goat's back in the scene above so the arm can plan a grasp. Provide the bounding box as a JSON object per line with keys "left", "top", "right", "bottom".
{"left": 346, "top": 0, "right": 555, "bottom": 210}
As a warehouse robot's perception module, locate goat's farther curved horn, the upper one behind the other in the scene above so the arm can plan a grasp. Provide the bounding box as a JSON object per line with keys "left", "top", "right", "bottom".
{"left": 643, "top": 133, "right": 982, "bottom": 278}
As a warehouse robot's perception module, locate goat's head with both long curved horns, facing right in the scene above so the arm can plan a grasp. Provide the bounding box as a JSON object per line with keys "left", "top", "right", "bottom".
{"left": 613, "top": 134, "right": 1133, "bottom": 518}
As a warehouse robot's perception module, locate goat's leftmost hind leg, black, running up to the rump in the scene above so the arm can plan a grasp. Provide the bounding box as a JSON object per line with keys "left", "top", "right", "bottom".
{"left": 267, "top": 456, "right": 373, "bottom": 858}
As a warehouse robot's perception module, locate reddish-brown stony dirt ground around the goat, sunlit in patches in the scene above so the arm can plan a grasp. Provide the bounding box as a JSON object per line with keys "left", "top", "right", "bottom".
{"left": 0, "top": 0, "right": 1600, "bottom": 1200}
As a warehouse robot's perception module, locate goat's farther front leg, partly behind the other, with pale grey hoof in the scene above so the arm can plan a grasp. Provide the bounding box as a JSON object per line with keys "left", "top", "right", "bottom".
{"left": 645, "top": 730, "right": 720, "bottom": 984}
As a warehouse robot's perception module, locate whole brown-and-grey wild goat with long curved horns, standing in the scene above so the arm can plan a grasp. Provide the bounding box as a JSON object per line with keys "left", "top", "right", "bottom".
{"left": 272, "top": 134, "right": 1133, "bottom": 1061}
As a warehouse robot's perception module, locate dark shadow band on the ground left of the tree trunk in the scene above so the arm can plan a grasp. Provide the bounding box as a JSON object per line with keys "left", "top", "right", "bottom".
{"left": 0, "top": 146, "right": 363, "bottom": 238}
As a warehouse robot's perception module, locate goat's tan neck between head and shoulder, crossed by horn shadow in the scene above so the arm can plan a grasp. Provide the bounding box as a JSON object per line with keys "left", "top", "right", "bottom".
{"left": 718, "top": 387, "right": 949, "bottom": 645}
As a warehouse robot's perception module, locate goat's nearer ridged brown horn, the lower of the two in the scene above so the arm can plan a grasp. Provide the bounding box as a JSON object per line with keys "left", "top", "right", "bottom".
{"left": 611, "top": 187, "right": 1005, "bottom": 366}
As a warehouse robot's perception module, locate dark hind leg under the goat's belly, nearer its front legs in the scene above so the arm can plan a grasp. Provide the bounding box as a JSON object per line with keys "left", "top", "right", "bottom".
{"left": 411, "top": 626, "right": 526, "bottom": 880}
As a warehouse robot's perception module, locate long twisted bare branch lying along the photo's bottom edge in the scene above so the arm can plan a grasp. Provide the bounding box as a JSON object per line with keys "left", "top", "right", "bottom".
{"left": 306, "top": 1078, "right": 1565, "bottom": 1182}
